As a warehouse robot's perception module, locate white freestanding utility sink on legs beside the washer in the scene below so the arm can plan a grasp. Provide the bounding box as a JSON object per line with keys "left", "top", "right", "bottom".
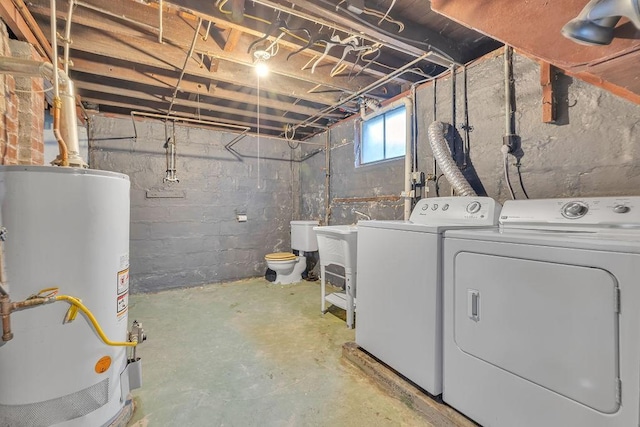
{"left": 313, "top": 225, "right": 358, "bottom": 328}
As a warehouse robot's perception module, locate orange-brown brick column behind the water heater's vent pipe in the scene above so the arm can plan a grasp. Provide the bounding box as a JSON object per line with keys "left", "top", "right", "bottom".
{"left": 0, "top": 22, "right": 44, "bottom": 165}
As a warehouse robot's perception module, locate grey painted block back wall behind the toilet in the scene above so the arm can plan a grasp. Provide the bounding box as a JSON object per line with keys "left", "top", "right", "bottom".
{"left": 89, "top": 115, "right": 298, "bottom": 292}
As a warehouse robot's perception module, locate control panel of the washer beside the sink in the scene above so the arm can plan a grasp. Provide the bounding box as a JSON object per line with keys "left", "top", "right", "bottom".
{"left": 409, "top": 196, "right": 502, "bottom": 225}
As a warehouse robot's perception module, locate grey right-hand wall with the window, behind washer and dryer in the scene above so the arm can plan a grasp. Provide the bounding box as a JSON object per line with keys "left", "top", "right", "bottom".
{"left": 300, "top": 50, "right": 640, "bottom": 224}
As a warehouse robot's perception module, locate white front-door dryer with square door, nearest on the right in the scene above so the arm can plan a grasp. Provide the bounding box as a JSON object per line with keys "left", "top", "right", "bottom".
{"left": 443, "top": 197, "right": 640, "bottom": 427}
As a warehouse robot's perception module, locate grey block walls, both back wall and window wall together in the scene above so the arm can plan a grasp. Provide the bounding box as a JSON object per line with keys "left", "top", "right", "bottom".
{"left": 89, "top": 49, "right": 640, "bottom": 292}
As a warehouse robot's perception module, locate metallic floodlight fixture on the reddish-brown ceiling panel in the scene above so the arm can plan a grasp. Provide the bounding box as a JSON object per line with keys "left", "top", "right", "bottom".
{"left": 562, "top": 0, "right": 640, "bottom": 45}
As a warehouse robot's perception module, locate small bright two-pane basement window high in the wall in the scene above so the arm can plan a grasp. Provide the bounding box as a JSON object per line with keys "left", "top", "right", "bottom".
{"left": 358, "top": 105, "right": 407, "bottom": 165}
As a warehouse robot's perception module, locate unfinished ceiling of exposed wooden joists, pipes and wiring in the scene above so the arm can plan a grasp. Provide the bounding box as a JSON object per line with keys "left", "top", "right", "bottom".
{"left": 2, "top": 0, "right": 500, "bottom": 139}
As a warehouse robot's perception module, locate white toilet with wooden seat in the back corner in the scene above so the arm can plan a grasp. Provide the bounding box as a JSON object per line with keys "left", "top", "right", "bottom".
{"left": 264, "top": 221, "right": 318, "bottom": 285}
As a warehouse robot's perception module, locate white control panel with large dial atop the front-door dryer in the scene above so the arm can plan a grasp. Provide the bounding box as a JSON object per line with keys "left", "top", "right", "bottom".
{"left": 500, "top": 196, "right": 640, "bottom": 228}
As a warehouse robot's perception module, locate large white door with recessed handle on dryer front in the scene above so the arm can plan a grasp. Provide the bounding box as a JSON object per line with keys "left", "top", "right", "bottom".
{"left": 454, "top": 249, "right": 619, "bottom": 413}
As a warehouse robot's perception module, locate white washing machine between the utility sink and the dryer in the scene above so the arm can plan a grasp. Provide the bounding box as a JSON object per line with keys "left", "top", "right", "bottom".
{"left": 356, "top": 197, "right": 500, "bottom": 395}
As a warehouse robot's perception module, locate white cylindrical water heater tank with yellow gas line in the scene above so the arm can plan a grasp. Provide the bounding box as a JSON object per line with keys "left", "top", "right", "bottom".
{"left": 0, "top": 166, "right": 130, "bottom": 427}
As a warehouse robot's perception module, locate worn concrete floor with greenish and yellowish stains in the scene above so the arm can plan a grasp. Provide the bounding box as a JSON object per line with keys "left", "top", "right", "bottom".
{"left": 129, "top": 279, "right": 430, "bottom": 427}
